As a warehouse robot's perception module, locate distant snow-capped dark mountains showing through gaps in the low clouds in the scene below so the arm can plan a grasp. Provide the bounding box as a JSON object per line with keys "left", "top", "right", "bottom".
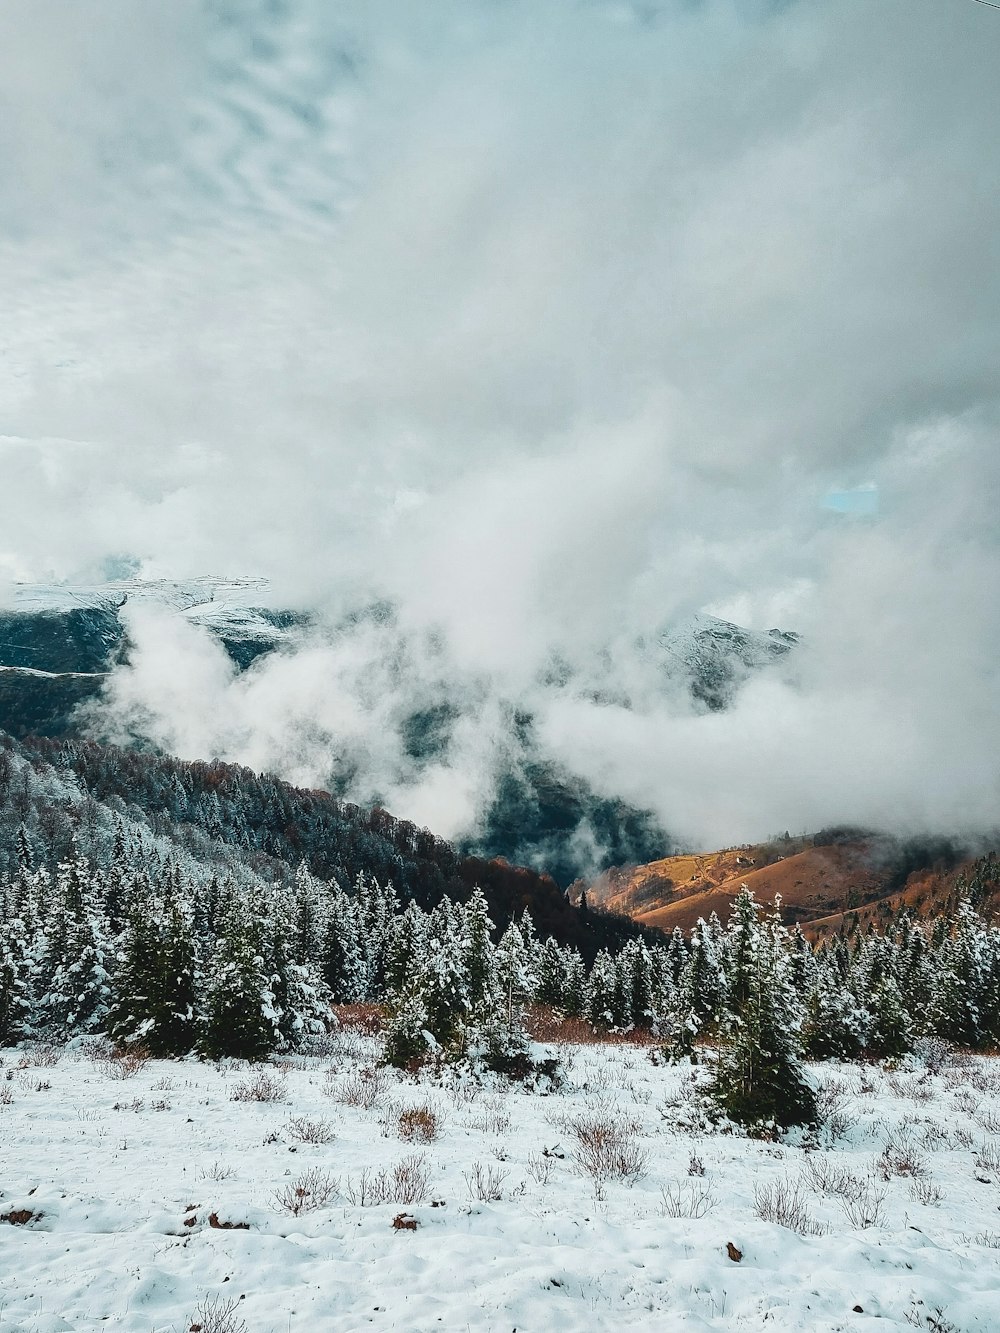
{"left": 0, "top": 577, "right": 797, "bottom": 885}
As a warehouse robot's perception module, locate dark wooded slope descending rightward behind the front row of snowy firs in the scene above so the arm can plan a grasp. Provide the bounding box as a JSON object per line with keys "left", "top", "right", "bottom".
{"left": 0, "top": 732, "right": 644, "bottom": 960}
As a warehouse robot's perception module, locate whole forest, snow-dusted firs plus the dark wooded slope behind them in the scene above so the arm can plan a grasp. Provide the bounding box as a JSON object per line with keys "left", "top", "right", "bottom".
{"left": 0, "top": 737, "right": 1000, "bottom": 1124}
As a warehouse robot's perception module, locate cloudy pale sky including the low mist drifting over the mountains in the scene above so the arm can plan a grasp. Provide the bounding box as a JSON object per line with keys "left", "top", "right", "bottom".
{"left": 0, "top": 0, "right": 1000, "bottom": 845}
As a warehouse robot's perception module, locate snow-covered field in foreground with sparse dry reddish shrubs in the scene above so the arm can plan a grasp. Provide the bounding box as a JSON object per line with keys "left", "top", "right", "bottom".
{"left": 0, "top": 1033, "right": 1000, "bottom": 1333}
